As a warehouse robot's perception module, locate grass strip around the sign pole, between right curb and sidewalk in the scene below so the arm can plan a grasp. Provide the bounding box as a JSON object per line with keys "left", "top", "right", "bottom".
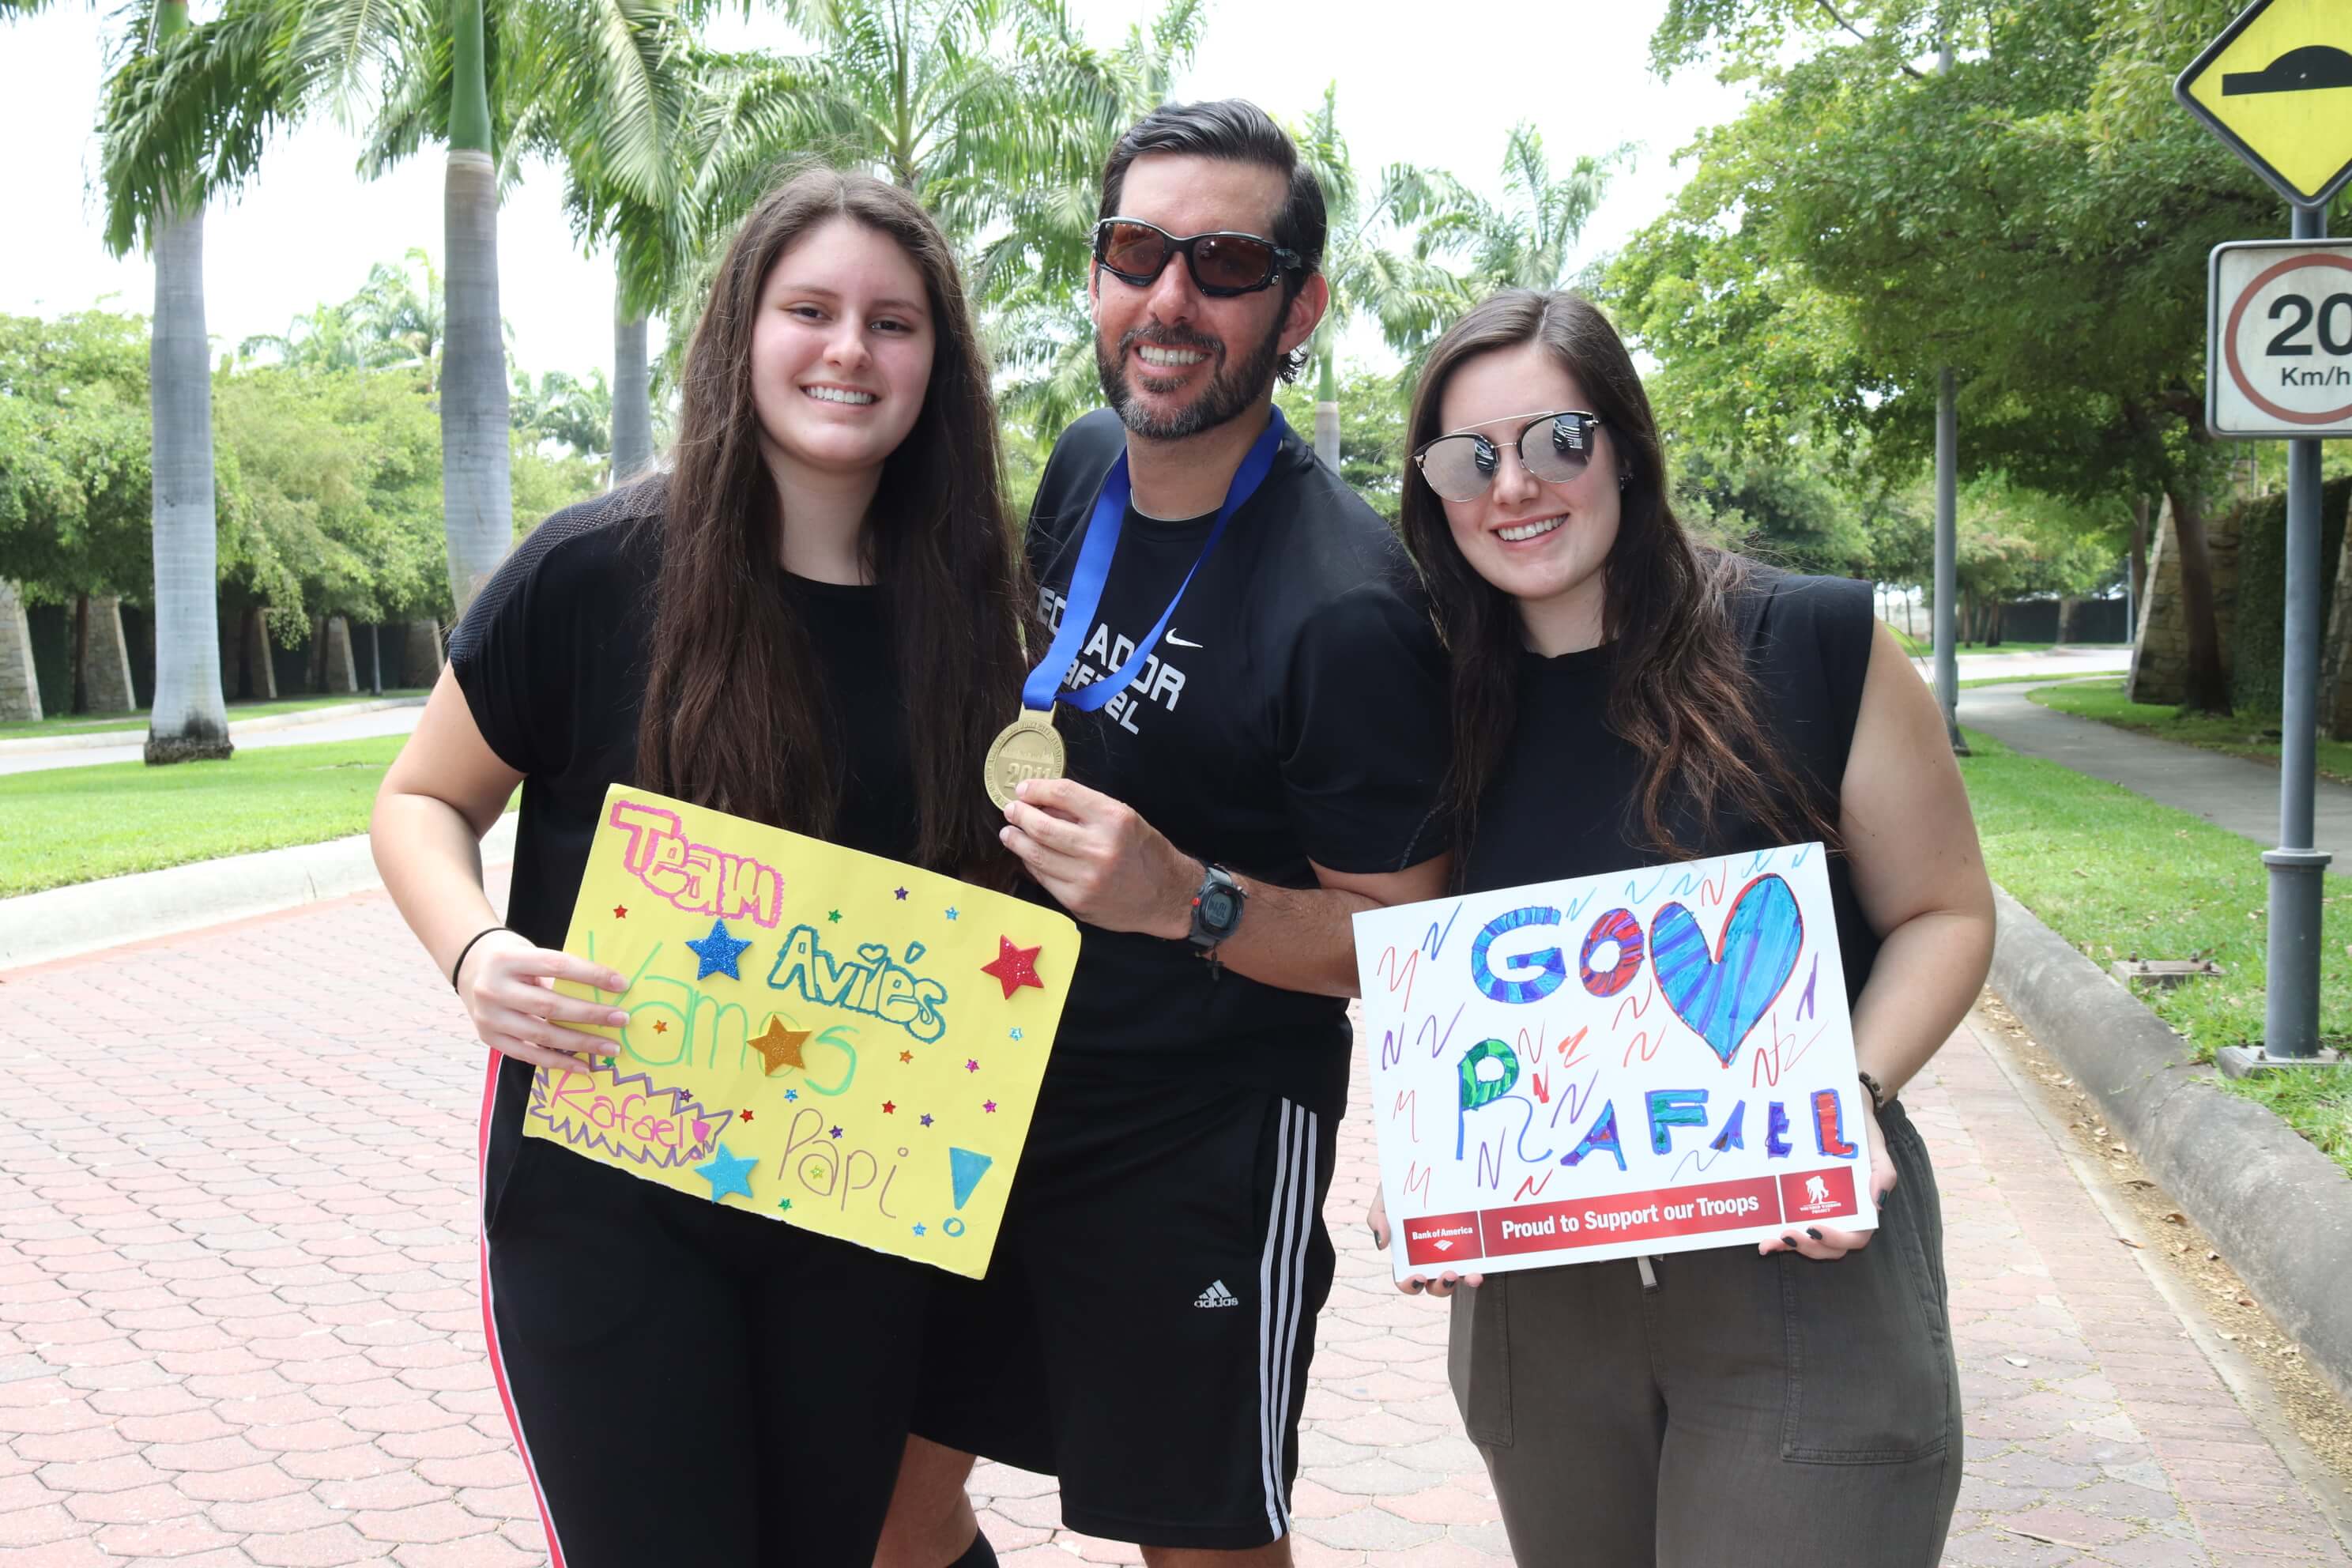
{"left": 1959, "top": 731, "right": 2352, "bottom": 1173}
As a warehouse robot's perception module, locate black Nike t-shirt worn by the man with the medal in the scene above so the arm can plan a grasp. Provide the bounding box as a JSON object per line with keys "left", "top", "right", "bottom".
{"left": 1028, "top": 409, "right": 1446, "bottom": 1114}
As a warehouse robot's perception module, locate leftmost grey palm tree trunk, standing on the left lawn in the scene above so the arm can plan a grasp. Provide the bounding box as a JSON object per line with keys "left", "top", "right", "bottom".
{"left": 146, "top": 184, "right": 236, "bottom": 762}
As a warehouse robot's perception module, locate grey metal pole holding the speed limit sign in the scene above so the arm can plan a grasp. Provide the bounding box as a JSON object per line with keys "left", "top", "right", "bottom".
{"left": 2263, "top": 207, "right": 2328, "bottom": 1061}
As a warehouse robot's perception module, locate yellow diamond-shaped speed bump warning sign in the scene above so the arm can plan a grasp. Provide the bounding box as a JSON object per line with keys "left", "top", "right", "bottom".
{"left": 2173, "top": 0, "right": 2352, "bottom": 207}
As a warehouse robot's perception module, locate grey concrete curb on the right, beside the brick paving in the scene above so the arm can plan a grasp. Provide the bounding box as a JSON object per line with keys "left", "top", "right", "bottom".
{"left": 1992, "top": 888, "right": 2352, "bottom": 1396}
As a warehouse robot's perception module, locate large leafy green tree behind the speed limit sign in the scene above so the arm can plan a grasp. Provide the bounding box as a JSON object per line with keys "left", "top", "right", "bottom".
{"left": 1609, "top": 0, "right": 2282, "bottom": 703}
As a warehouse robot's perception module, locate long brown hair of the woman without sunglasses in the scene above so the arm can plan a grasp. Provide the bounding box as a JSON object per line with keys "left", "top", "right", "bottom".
{"left": 637, "top": 169, "right": 1030, "bottom": 881}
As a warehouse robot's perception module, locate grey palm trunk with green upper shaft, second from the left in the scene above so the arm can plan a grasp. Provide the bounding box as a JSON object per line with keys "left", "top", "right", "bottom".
{"left": 440, "top": 0, "right": 515, "bottom": 616}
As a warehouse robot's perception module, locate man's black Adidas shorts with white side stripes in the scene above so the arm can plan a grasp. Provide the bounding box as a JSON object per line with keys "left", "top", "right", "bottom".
{"left": 915, "top": 1067, "right": 1336, "bottom": 1549}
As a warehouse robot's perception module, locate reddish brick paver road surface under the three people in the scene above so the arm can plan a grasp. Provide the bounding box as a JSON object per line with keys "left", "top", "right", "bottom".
{"left": 0, "top": 895, "right": 2352, "bottom": 1568}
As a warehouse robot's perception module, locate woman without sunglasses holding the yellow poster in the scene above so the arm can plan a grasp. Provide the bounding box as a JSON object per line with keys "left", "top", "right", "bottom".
{"left": 374, "top": 169, "right": 1028, "bottom": 1568}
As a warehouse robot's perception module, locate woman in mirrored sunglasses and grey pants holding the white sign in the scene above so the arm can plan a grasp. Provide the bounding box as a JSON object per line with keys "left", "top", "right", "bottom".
{"left": 1374, "top": 289, "right": 1992, "bottom": 1568}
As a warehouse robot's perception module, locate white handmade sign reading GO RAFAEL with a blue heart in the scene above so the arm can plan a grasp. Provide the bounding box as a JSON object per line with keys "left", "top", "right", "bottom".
{"left": 1355, "top": 844, "right": 1877, "bottom": 1279}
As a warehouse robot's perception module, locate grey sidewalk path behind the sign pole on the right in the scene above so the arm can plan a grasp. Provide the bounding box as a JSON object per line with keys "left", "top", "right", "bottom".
{"left": 1959, "top": 684, "right": 2352, "bottom": 870}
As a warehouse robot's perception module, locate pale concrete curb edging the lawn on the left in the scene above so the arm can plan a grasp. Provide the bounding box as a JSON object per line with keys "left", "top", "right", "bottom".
{"left": 0, "top": 811, "right": 515, "bottom": 971}
